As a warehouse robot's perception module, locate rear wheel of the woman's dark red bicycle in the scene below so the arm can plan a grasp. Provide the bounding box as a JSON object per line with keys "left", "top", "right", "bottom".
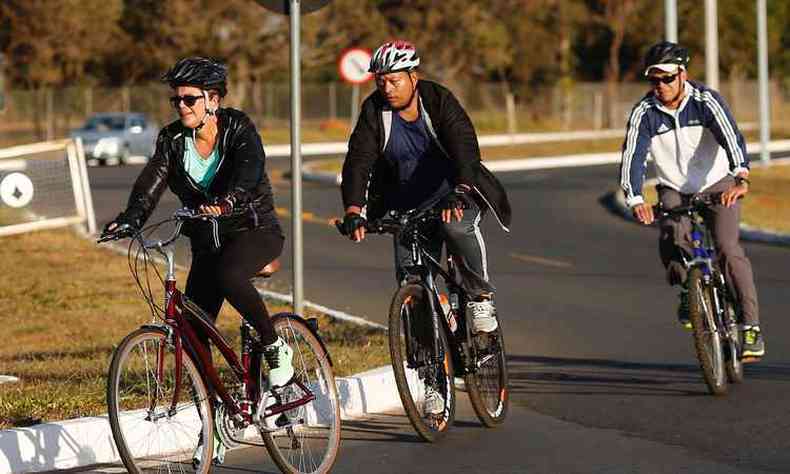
{"left": 261, "top": 314, "right": 341, "bottom": 474}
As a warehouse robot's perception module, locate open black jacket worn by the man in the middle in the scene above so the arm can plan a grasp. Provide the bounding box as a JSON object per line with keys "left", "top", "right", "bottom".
{"left": 342, "top": 80, "right": 511, "bottom": 230}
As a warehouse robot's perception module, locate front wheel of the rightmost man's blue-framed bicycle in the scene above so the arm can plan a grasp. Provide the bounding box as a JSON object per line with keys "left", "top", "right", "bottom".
{"left": 688, "top": 267, "right": 727, "bottom": 395}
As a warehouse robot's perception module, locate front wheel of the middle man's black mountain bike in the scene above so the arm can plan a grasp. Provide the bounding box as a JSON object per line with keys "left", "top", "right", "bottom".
{"left": 389, "top": 284, "right": 456, "bottom": 443}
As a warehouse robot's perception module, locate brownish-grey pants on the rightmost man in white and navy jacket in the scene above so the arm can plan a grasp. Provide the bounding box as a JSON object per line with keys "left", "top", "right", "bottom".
{"left": 656, "top": 176, "right": 760, "bottom": 325}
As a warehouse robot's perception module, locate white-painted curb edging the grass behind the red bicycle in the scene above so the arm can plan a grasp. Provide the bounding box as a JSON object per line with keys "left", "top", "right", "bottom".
{"left": 0, "top": 366, "right": 401, "bottom": 473}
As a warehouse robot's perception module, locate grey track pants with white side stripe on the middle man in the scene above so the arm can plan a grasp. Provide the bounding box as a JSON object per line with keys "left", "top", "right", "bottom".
{"left": 394, "top": 204, "right": 495, "bottom": 298}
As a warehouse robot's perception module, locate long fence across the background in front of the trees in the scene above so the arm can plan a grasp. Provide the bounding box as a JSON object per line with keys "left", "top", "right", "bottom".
{"left": 0, "top": 81, "right": 790, "bottom": 144}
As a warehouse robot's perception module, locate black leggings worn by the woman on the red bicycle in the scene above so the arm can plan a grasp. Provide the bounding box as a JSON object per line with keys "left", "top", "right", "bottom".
{"left": 184, "top": 229, "right": 284, "bottom": 344}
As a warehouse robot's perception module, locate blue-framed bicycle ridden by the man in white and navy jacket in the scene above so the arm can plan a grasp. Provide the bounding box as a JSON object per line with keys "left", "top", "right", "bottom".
{"left": 655, "top": 194, "right": 743, "bottom": 395}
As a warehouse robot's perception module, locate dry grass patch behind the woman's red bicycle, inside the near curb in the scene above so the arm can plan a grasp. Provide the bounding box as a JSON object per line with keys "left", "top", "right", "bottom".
{"left": 0, "top": 230, "right": 389, "bottom": 429}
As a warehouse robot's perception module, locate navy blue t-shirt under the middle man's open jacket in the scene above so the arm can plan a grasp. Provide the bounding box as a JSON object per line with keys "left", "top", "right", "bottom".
{"left": 384, "top": 112, "right": 453, "bottom": 211}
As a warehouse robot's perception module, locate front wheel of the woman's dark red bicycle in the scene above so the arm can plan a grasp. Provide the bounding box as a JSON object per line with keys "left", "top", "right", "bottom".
{"left": 107, "top": 328, "right": 214, "bottom": 473}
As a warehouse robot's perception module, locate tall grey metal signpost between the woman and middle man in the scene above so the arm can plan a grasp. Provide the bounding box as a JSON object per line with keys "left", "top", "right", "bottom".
{"left": 290, "top": 0, "right": 304, "bottom": 314}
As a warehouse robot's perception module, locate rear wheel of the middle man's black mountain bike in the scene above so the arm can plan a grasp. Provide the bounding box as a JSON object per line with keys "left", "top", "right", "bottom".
{"left": 464, "top": 316, "right": 510, "bottom": 428}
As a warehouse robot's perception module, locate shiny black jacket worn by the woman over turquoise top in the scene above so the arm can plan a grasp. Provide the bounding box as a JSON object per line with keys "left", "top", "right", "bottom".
{"left": 116, "top": 108, "right": 282, "bottom": 247}
